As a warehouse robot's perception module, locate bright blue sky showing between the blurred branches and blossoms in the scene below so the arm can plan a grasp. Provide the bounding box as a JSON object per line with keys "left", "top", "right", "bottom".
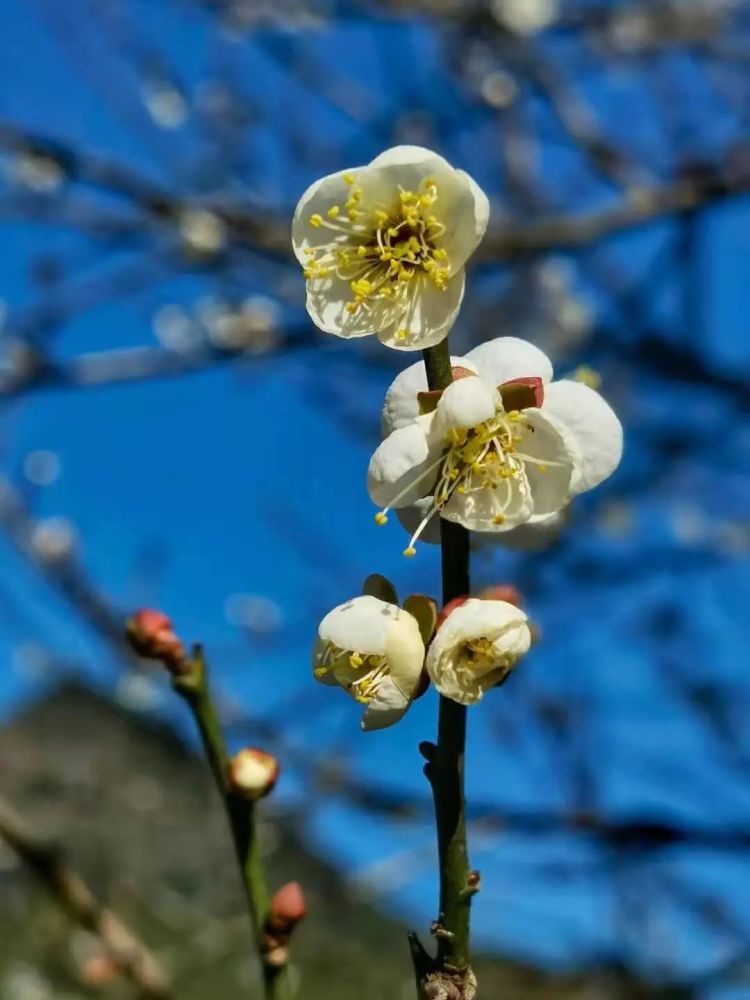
{"left": 0, "top": 0, "right": 750, "bottom": 984}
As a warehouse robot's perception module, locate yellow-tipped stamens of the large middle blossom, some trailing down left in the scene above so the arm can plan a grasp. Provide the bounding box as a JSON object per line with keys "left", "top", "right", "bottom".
{"left": 375, "top": 407, "right": 562, "bottom": 556}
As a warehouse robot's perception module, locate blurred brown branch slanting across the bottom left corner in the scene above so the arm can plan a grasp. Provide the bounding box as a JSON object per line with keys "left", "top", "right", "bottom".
{"left": 0, "top": 799, "right": 174, "bottom": 1000}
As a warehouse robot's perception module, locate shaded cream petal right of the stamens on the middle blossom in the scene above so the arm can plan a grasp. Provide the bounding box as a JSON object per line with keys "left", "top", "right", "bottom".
{"left": 515, "top": 408, "right": 577, "bottom": 519}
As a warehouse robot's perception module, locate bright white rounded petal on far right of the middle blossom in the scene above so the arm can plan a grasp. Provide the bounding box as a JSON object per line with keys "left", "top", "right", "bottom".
{"left": 543, "top": 380, "right": 622, "bottom": 495}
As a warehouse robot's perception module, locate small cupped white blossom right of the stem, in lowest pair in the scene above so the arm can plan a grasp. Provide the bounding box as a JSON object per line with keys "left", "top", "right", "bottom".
{"left": 426, "top": 598, "right": 531, "bottom": 705}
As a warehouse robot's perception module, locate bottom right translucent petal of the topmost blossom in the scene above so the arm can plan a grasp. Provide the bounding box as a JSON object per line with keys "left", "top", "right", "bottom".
{"left": 378, "top": 271, "right": 465, "bottom": 351}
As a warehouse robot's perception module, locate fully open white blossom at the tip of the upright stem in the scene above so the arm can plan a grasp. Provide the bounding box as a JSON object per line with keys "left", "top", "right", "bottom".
{"left": 292, "top": 146, "right": 489, "bottom": 351}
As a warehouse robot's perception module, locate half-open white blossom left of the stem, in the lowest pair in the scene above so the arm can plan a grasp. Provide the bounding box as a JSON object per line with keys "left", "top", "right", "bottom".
{"left": 313, "top": 595, "right": 425, "bottom": 730}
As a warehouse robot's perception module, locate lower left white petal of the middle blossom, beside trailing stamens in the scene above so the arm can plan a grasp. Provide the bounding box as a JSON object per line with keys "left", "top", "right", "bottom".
{"left": 367, "top": 417, "right": 440, "bottom": 507}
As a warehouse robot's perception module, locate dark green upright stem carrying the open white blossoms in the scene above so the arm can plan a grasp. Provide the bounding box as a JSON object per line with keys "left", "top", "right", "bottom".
{"left": 424, "top": 339, "right": 472, "bottom": 969}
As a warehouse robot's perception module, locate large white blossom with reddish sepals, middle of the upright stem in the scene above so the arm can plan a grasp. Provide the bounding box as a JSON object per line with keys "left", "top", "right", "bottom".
{"left": 368, "top": 337, "right": 622, "bottom": 555}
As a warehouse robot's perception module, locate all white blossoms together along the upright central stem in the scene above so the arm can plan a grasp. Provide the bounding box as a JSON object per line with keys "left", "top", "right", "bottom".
{"left": 292, "top": 146, "right": 622, "bottom": 729}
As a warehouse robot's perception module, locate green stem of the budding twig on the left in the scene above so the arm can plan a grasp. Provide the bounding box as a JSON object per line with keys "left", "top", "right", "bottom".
{"left": 173, "top": 646, "right": 291, "bottom": 1000}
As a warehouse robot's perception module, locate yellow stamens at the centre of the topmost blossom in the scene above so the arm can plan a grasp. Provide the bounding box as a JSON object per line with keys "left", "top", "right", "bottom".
{"left": 304, "top": 174, "right": 450, "bottom": 339}
